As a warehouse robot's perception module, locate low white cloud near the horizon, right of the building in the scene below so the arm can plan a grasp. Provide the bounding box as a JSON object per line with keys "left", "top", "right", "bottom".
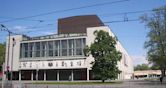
{"left": 132, "top": 56, "right": 148, "bottom": 66}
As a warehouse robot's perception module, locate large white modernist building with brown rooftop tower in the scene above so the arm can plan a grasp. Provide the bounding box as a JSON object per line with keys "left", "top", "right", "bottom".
{"left": 5, "top": 15, "right": 133, "bottom": 81}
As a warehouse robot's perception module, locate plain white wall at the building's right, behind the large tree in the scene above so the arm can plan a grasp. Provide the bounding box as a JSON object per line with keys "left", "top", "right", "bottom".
{"left": 86, "top": 26, "right": 133, "bottom": 79}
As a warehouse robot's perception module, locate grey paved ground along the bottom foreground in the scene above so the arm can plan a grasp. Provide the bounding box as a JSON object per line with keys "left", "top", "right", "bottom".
{"left": 0, "top": 80, "right": 166, "bottom": 88}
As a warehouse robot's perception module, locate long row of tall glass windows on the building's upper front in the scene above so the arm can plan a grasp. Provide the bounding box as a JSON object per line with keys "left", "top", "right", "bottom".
{"left": 20, "top": 38, "right": 86, "bottom": 58}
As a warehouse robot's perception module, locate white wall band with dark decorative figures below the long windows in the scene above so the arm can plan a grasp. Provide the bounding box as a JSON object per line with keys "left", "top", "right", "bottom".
{"left": 20, "top": 59, "right": 86, "bottom": 70}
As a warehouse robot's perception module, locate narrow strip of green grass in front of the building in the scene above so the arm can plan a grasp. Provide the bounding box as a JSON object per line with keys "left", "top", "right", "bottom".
{"left": 30, "top": 81, "right": 123, "bottom": 85}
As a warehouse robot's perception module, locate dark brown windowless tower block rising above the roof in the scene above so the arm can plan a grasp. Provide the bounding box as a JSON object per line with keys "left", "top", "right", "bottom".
{"left": 58, "top": 15, "right": 104, "bottom": 34}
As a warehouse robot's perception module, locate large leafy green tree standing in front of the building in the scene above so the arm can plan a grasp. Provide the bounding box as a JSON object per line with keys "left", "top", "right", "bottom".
{"left": 85, "top": 30, "right": 122, "bottom": 82}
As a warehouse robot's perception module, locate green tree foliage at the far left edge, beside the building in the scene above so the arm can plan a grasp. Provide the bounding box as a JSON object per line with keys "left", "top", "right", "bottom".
{"left": 0, "top": 43, "right": 5, "bottom": 70}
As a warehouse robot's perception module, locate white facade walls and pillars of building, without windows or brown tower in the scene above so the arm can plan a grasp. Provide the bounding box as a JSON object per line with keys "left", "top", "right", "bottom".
{"left": 5, "top": 26, "right": 133, "bottom": 80}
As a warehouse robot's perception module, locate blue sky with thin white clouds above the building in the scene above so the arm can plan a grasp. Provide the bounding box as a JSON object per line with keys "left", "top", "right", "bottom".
{"left": 0, "top": 0, "right": 166, "bottom": 65}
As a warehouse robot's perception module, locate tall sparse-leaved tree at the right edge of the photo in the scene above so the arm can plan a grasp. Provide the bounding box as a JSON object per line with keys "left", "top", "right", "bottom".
{"left": 141, "top": 6, "right": 166, "bottom": 76}
